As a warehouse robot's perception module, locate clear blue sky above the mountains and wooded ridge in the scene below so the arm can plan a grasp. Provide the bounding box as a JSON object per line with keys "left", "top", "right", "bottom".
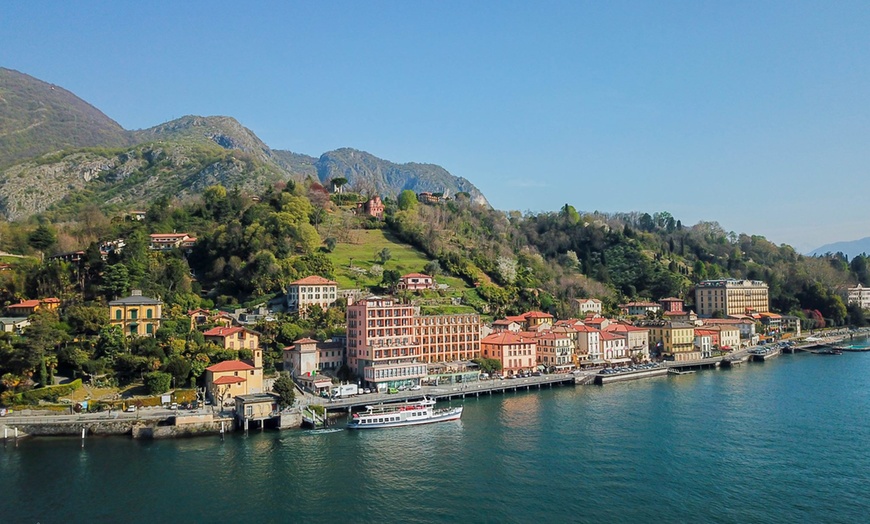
{"left": 0, "top": 0, "right": 870, "bottom": 252}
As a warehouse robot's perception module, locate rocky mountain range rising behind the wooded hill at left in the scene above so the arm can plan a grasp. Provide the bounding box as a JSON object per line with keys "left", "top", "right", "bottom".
{"left": 0, "top": 68, "right": 489, "bottom": 220}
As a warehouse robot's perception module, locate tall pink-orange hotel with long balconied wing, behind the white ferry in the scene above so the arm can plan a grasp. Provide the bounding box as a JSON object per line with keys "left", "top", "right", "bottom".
{"left": 347, "top": 296, "right": 480, "bottom": 390}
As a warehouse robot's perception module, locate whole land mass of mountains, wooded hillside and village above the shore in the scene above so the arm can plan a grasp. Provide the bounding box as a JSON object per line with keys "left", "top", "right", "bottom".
{"left": 0, "top": 69, "right": 870, "bottom": 418}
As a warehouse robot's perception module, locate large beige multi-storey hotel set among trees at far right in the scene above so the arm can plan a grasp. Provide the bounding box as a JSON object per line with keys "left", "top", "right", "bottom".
{"left": 695, "top": 278, "right": 770, "bottom": 317}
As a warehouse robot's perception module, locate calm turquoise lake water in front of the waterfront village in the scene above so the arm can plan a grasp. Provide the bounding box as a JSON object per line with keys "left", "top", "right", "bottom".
{"left": 0, "top": 353, "right": 870, "bottom": 523}
